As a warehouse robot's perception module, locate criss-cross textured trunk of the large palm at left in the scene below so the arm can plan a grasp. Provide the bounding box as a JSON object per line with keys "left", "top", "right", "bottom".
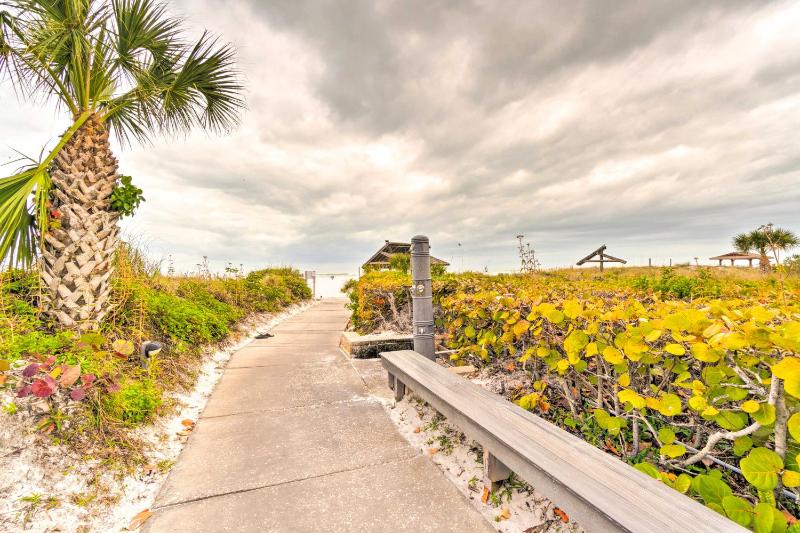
{"left": 41, "top": 117, "right": 118, "bottom": 330}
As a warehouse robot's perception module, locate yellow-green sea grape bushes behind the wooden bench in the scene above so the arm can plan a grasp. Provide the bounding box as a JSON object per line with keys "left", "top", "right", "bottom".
{"left": 348, "top": 275, "right": 800, "bottom": 532}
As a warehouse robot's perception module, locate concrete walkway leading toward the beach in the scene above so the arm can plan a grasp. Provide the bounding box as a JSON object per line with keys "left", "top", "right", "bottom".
{"left": 145, "top": 299, "right": 494, "bottom": 533}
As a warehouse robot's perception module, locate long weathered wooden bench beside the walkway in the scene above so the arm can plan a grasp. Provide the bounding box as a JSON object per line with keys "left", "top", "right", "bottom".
{"left": 381, "top": 350, "right": 747, "bottom": 533}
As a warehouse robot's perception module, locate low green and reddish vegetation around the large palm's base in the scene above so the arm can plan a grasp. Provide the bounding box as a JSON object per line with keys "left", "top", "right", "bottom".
{"left": 0, "top": 247, "right": 311, "bottom": 461}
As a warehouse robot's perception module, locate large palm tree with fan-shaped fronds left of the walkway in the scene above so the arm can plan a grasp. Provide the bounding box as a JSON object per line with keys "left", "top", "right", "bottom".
{"left": 0, "top": 0, "right": 244, "bottom": 329}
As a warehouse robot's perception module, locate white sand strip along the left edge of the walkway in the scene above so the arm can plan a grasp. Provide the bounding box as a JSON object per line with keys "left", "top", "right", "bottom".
{"left": 0, "top": 302, "right": 312, "bottom": 532}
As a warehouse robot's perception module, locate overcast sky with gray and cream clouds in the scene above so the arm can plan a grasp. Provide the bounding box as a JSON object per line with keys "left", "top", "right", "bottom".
{"left": 0, "top": 0, "right": 800, "bottom": 274}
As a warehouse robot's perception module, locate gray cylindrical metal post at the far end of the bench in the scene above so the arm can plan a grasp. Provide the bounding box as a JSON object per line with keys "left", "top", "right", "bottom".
{"left": 411, "top": 235, "right": 436, "bottom": 360}
